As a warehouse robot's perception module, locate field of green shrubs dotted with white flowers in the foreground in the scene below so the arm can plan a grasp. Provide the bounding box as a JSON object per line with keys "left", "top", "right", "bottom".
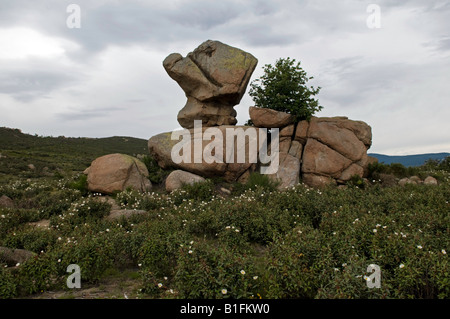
{"left": 0, "top": 172, "right": 450, "bottom": 299}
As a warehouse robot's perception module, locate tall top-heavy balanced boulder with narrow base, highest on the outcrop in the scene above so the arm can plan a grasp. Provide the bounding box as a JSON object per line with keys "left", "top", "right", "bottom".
{"left": 163, "top": 40, "right": 258, "bottom": 128}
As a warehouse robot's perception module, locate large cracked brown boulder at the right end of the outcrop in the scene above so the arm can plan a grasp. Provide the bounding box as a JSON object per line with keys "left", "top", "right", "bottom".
{"left": 300, "top": 117, "right": 373, "bottom": 187}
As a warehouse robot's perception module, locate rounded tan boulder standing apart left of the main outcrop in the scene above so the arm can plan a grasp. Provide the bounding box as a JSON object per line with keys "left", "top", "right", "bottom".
{"left": 87, "top": 153, "right": 152, "bottom": 194}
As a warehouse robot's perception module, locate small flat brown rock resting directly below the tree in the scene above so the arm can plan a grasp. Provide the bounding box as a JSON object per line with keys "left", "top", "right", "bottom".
{"left": 249, "top": 106, "right": 294, "bottom": 128}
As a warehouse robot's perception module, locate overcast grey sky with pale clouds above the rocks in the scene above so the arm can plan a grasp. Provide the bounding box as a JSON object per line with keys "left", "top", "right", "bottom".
{"left": 0, "top": 0, "right": 450, "bottom": 155}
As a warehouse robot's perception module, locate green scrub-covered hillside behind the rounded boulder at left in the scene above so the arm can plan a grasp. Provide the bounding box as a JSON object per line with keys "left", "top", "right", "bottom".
{"left": 0, "top": 127, "right": 148, "bottom": 177}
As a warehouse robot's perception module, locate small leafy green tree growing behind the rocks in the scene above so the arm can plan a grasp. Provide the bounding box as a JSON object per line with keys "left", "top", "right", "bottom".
{"left": 248, "top": 57, "right": 322, "bottom": 124}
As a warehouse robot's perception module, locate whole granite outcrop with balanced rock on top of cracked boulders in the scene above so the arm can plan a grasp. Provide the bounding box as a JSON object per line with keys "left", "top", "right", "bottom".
{"left": 148, "top": 40, "right": 374, "bottom": 190}
